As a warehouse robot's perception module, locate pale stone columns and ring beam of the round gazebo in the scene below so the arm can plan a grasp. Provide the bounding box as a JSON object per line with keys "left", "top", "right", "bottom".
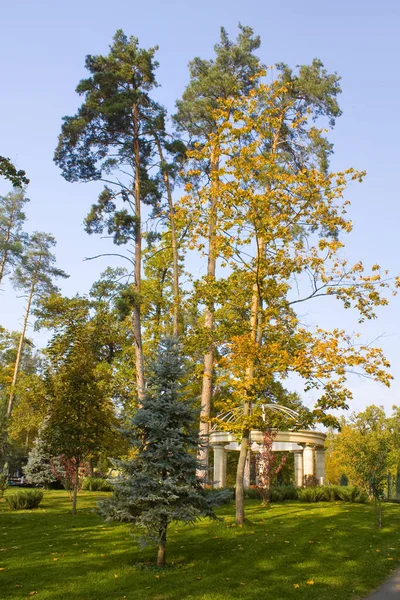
{"left": 209, "top": 429, "right": 326, "bottom": 488}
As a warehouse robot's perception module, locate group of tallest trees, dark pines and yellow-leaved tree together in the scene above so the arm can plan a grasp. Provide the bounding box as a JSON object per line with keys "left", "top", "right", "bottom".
{"left": 55, "top": 27, "right": 396, "bottom": 523}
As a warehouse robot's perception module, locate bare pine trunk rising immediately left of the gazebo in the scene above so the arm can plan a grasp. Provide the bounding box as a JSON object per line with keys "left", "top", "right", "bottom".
{"left": 198, "top": 148, "right": 219, "bottom": 481}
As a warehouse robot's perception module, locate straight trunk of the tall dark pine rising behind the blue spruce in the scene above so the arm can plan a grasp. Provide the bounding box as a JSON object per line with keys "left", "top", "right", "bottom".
{"left": 132, "top": 104, "right": 145, "bottom": 404}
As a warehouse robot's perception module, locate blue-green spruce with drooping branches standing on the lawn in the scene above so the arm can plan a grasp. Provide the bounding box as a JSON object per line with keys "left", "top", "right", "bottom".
{"left": 100, "top": 339, "right": 227, "bottom": 567}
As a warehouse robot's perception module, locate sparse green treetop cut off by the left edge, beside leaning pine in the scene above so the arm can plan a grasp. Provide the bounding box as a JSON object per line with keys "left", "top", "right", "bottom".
{"left": 0, "top": 190, "right": 29, "bottom": 285}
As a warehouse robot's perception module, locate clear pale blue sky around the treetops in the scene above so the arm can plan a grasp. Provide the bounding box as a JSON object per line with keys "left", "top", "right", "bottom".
{"left": 0, "top": 0, "right": 400, "bottom": 412}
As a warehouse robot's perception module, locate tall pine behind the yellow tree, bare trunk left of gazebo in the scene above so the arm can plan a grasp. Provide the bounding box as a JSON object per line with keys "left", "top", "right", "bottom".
{"left": 174, "top": 25, "right": 260, "bottom": 476}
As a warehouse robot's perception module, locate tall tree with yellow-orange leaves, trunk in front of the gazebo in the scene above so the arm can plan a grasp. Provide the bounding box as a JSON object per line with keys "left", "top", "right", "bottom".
{"left": 182, "top": 65, "right": 396, "bottom": 523}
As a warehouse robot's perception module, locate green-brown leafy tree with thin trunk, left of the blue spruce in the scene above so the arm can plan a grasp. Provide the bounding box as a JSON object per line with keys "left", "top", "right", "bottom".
{"left": 38, "top": 296, "right": 122, "bottom": 514}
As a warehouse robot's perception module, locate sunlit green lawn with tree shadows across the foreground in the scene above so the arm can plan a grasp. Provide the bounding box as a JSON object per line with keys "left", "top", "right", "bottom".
{"left": 0, "top": 492, "right": 400, "bottom": 600}
